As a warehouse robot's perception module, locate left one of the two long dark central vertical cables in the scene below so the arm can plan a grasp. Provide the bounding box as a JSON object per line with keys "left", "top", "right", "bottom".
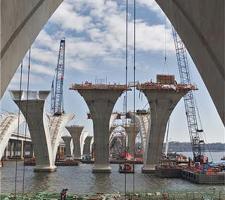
{"left": 124, "top": 0, "right": 128, "bottom": 197}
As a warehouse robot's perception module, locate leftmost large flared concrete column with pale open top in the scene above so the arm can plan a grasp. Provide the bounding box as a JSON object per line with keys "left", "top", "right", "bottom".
{"left": 11, "top": 91, "right": 56, "bottom": 172}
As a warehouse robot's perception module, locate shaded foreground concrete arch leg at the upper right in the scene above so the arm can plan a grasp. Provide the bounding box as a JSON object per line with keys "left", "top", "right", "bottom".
{"left": 156, "top": 0, "right": 225, "bottom": 125}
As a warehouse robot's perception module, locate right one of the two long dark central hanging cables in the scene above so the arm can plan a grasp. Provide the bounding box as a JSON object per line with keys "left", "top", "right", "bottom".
{"left": 133, "top": 0, "right": 136, "bottom": 194}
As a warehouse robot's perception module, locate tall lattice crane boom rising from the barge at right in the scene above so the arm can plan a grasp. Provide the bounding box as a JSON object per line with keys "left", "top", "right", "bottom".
{"left": 172, "top": 28, "right": 205, "bottom": 163}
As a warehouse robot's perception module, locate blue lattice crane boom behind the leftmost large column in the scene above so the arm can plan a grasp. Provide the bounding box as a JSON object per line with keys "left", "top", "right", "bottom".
{"left": 51, "top": 39, "right": 65, "bottom": 115}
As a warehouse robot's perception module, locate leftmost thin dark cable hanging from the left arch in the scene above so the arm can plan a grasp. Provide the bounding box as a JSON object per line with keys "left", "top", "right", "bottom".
{"left": 14, "top": 61, "right": 23, "bottom": 199}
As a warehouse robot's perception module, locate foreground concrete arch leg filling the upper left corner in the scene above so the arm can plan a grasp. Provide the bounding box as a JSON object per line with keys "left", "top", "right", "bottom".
{"left": 0, "top": 0, "right": 63, "bottom": 98}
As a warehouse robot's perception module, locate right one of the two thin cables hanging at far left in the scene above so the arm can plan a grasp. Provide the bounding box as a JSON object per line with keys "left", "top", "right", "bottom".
{"left": 22, "top": 49, "right": 31, "bottom": 195}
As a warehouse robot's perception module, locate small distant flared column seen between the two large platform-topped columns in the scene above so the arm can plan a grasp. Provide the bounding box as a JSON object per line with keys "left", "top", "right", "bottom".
{"left": 124, "top": 124, "right": 138, "bottom": 154}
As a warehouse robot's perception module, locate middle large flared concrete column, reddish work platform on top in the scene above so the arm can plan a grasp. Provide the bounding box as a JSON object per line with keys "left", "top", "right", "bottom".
{"left": 71, "top": 84, "right": 127, "bottom": 173}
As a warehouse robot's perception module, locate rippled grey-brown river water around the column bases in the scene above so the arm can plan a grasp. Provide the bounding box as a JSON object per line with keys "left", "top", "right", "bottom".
{"left": 0, "top": 152, "right": 225, "bottom": 194}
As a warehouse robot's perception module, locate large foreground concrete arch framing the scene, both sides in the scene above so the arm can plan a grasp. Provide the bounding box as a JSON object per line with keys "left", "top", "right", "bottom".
{"left": 1, "top": 0, "right": 225, "bottom": 124}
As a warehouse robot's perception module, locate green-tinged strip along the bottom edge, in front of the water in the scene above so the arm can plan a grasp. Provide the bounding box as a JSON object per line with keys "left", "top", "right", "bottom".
{"left": 0, "top": 191, "right": 225, "bottom": 200}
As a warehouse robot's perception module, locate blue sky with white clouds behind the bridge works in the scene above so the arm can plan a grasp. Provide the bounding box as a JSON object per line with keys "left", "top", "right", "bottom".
{"left": 1, "top": 0, "right": 225, "bottom": 142}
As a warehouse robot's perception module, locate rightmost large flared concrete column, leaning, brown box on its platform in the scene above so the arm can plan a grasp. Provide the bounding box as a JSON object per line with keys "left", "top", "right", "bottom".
{"left": 138, "top": 84, "right": 191, "bottom": 173}
